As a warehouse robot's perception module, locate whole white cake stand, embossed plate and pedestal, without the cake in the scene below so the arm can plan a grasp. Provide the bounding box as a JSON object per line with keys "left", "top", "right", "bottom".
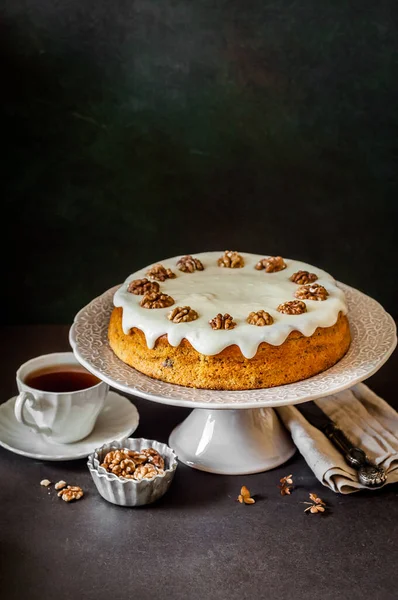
{"left": 69, "top": 284, "right": 397, "bottom": 475}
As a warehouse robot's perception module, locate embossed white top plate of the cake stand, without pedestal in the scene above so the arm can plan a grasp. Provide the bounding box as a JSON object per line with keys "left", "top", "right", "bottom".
{"left": 69, "top": 283, "right": 397, "bottom": 409}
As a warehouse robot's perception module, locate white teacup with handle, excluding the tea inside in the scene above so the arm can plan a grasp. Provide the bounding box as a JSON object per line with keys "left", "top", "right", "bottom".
{"left": 14, "top": 352, "right": 109, "bottom": 444}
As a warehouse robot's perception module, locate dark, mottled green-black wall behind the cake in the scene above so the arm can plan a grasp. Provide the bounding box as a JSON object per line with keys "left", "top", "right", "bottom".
{"left": 0, "top": 0, "right": 398, "bottom": 323}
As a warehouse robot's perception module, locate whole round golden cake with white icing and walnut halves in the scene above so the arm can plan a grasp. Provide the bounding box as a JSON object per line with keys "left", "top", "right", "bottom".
{"left": 108, "top": 251, "right": 351, "bottom": 390}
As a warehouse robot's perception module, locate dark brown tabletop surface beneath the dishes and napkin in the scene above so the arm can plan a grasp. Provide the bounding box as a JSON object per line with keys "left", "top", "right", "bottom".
{"left": 0, "top": 326, "right": 398, "bottom": 600}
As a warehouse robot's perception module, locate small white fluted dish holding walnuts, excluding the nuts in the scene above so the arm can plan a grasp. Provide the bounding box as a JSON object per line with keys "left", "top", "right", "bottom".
{"left": 87, "top": 438, "right": 178, "bottom": 506}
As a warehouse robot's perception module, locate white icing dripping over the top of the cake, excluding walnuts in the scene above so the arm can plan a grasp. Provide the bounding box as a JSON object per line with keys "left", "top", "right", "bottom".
{"left": 114, "top": 251, "right": 347, "bottom": 358}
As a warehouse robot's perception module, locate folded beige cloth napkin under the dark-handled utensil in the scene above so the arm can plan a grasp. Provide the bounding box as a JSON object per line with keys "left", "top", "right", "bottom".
{"left": 277, "top": 383, "right": 398, "bottom": 494}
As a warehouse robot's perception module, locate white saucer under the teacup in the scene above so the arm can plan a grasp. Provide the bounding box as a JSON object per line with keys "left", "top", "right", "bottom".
{"left": 0, "top": 392, "right": 139, "bottom": 461}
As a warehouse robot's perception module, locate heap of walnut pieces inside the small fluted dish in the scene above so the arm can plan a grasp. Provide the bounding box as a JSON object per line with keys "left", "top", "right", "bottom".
{"left": 101, "top": 448, "right": 164, "bottom": 479}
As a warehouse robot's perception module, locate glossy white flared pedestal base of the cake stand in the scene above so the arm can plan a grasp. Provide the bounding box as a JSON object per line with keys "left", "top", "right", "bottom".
{"left": 169, "top": 408, "right": 296, "bottom": 475}
